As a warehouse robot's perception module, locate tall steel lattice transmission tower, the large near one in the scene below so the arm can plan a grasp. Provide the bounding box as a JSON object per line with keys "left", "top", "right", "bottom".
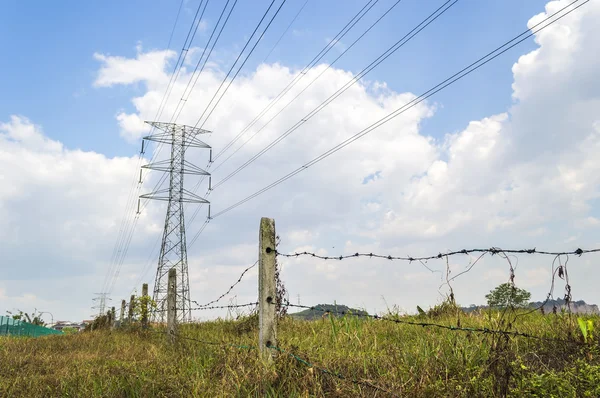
{"left": 140, "top": 122, "right": 212, "bottom": 322}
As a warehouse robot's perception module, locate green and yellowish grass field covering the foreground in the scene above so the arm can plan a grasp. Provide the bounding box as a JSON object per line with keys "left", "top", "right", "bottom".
{"left": 0, "top": 313, "right": 600, "bottom": 398}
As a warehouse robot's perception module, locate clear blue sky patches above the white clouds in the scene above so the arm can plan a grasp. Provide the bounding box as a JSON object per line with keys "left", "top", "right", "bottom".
{"left": 0, "top": 0, "right": 544, "bottom": 156}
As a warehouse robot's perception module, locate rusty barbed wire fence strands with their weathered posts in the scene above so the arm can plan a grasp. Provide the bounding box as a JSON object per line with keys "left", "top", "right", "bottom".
{"left": 118, "top": 218, "right": 600, "bottom": 396}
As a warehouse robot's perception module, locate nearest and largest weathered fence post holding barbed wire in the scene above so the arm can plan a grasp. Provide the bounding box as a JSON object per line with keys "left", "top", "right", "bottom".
{"left": 258, "top": 217, "right": 277, "bottom": 360}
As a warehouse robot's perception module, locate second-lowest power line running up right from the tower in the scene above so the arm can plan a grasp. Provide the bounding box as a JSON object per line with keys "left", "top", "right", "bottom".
{"left": 214, "top": 0, "right": 458, "bottom": 189}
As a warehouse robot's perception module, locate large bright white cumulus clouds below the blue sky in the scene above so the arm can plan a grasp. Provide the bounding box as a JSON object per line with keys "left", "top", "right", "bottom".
{"left": 0, "top": 1, "right": 600, "bottom": 316}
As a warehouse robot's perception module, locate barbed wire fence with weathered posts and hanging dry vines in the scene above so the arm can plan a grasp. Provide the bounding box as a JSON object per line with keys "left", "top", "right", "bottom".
{"left": 113, "top": 218, "right": 600, "bottom": 396}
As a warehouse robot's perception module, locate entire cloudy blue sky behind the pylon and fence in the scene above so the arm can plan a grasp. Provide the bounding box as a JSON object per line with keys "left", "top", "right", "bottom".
{"left": 0, "top": 0, "right": 600, "bottom": 319}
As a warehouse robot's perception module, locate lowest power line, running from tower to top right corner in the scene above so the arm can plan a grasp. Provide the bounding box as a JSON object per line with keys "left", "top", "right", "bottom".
{"left": 212, "top": 0, "right": 590, "bottom": 218}
